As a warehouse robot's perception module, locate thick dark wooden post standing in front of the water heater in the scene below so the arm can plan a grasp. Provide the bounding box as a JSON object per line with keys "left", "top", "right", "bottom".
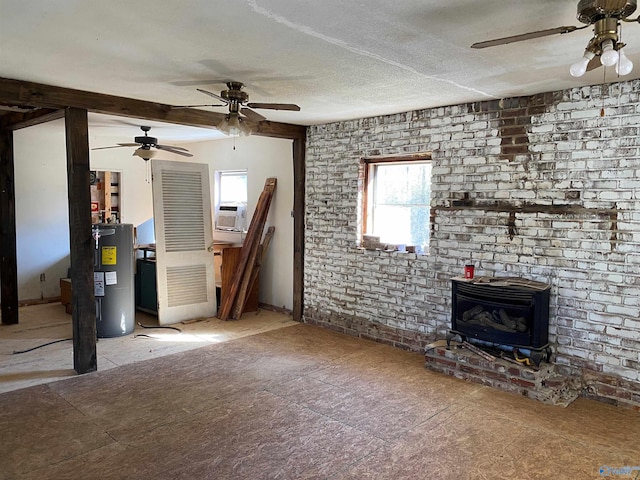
{"left": 65, "top": 107, "right": 97, "bottom": 374}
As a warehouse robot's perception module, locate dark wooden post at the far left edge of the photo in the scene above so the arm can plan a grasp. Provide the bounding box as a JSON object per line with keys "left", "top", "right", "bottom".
{"left": 0, "top": 128, "right": 18, "bottom": 325}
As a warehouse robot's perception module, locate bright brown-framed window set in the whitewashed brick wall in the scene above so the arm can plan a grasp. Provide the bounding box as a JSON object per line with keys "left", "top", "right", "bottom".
{"left": 362, "top": 154, "right": 431, "bottom": 251}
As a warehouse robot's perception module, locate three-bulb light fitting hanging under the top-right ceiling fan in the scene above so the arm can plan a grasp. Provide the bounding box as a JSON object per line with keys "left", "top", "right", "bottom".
{"left": 569, "top": 15, "right": 633, "bottom": 77}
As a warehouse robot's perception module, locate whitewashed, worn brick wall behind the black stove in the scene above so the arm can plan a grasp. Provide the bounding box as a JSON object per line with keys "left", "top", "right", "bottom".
{"left": 304, "top": 80, "right": 640, "bottom": 405}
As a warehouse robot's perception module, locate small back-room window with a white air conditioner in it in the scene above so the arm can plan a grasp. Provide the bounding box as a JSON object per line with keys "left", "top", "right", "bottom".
{"left": 215, "top": 170, "right": 247, "bottom": 232}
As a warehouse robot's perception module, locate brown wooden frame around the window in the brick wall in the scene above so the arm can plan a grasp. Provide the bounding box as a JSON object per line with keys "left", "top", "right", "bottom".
{"left": 359, "top": 152, "right": 433, "bottom": 253}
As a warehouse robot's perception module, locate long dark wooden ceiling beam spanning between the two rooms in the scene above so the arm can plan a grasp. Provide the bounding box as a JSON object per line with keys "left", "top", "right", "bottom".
{"left": 0, "top": 77, "right": 306, "bottom": 139}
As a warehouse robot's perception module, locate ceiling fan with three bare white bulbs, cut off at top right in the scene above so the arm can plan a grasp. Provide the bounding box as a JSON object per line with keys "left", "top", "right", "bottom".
{"left": 471, "top": 0, "right": 640, "bottom": 77}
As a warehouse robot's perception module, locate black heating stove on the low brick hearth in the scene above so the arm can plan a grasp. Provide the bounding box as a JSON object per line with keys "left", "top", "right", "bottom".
{"left": 447, "top": 277, "right": 550, "bottom": 365}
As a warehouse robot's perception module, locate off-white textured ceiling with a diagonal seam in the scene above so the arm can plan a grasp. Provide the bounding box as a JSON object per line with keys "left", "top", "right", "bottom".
{"left": 0, "top": 0, "right": 640, "bottom": 141}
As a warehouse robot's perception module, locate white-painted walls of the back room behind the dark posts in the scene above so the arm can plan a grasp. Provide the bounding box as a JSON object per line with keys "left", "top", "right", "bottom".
{"left": 14, "top": 124, "right": 293, "bottom": 309}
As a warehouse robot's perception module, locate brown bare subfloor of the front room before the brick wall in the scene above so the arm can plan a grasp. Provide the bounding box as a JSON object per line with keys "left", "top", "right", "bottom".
{"left": 0, "top": 304, "right": 640, "bottom": 480}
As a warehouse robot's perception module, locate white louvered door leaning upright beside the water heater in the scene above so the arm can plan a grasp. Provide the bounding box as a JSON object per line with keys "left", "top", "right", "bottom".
{"left": 151, "top": 160, "right": 217, "bottom": 325}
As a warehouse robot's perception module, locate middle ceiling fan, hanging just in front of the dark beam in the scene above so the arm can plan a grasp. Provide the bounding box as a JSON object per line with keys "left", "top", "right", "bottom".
{"left": 174, "top": 80, "right": 300, "bottom": 136}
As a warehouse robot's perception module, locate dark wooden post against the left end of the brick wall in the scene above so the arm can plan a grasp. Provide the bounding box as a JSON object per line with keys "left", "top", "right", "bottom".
{"left": 293, "top": 135, "right": 306, "bottom": 322}
